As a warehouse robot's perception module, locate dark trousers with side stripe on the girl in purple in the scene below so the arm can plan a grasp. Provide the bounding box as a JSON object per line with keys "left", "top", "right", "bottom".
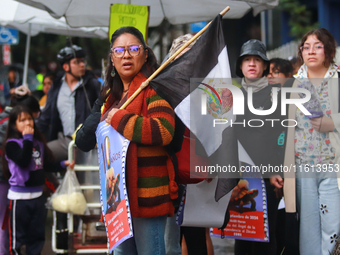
{"left": 9, "top": 196, "right": 46, "bottom": 255}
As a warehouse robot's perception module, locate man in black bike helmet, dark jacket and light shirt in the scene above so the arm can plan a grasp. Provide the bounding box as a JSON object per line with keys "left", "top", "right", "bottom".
{"left": 37, "top": 45, "right": 101, "bottom": 160}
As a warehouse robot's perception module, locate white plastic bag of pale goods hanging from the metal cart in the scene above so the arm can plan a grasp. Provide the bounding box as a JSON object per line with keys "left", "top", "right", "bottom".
{"left": 51, "top": 170, "right": 87, "bottom": 215}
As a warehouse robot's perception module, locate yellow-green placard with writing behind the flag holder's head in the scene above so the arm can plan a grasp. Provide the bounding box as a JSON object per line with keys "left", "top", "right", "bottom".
{"left": 109, "top": 4, "right": 150, "bottom": 43}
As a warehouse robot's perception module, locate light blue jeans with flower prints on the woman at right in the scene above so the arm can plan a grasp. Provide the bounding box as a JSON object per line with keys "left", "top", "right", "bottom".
{"left": 296, "top": 165, "right": 340, "bottom": 255}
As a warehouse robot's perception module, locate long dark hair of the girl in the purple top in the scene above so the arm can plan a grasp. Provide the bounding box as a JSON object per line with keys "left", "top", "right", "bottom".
{"left": 2, "top": 105, "right": 54, "bottom": 179}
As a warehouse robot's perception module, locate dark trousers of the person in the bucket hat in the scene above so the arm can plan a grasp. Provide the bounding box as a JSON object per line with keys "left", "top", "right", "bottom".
{"left": 235, "top": 179, "right": 280, "bottom": 255}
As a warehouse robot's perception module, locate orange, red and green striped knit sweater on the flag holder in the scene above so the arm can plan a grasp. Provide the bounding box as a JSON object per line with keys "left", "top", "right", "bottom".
{"left": 103, "top": 73, "right": 178, "bottom": 218}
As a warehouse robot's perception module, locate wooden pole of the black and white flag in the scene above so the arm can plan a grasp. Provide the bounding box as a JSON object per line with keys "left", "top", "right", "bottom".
{"left": 119, "top": 6, "right": 230, "bottom": 109}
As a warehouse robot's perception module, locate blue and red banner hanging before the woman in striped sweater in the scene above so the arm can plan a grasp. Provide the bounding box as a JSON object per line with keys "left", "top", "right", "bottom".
{"left": 96, "top": 121, "right": 133, "bottom": 252}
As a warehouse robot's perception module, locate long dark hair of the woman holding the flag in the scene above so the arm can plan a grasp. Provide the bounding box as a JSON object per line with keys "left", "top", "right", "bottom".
{"left": 102, "top": 27, "right": 159, "bottom": 105}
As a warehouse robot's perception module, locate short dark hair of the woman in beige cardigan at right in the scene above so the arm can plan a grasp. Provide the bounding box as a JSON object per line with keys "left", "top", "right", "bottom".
{"left": 298, "top": 28, "right": 337, "bottom": 67}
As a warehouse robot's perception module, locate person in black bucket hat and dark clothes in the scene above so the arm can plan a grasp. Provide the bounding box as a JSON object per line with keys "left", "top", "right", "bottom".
{"left": 235, "top": 39, "right": 283, "bottom": 255}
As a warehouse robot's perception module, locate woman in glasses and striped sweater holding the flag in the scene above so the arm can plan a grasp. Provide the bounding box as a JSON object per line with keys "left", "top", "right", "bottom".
{"left": 76, "top": 27, "right": 178, "bottom": 255}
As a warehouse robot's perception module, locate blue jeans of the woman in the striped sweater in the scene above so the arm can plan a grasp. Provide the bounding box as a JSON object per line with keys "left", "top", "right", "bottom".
{"left": 113, "top": 215, "right": 167, "bottom": 255}
